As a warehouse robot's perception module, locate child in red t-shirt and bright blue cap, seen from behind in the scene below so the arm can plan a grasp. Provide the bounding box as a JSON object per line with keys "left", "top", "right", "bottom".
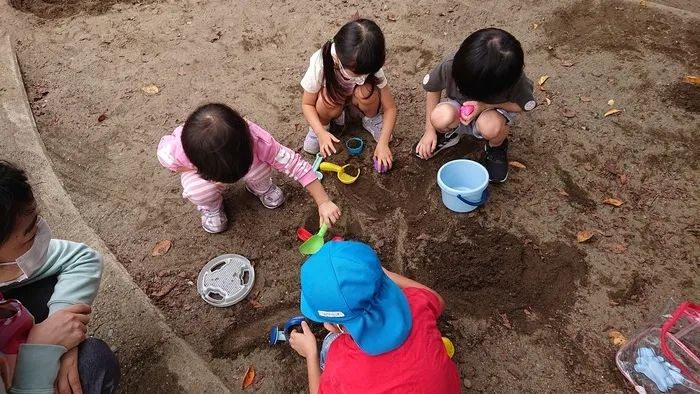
{"left": 289, "top": 241, "right": 460, "bottom": 394}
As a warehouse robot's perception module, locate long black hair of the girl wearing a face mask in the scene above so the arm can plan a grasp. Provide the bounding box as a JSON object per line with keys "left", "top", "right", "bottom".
{"left": 321, "top": 19, "right": 386, "bottom": 105}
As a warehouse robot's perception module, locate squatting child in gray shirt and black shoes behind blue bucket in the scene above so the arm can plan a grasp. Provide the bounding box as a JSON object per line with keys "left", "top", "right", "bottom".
{"left": 413, "top": 28, "right": 537, "bottom": 182}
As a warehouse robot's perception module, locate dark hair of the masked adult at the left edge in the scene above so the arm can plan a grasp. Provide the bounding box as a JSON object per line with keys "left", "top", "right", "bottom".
{"left": 0, "top": 160, "right": 34, "bottom": 245}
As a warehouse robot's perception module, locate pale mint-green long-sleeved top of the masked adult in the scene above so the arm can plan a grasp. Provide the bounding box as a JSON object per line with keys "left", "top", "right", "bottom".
{"left": 0, "top": 239, "right": 102, "bottom": 394}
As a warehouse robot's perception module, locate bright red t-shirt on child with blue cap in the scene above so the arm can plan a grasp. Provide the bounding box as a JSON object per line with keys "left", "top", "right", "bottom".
{"left": 319, "top": 288, "right": 460, "bottom": 394}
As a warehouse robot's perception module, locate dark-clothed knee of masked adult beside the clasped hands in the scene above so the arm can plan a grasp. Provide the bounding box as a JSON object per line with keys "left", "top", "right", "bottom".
{"left": 78, "top": 338, "right": 121, "bottom": 394}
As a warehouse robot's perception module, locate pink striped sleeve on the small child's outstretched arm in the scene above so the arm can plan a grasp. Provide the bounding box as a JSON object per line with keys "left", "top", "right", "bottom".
{"left": 248, "top": 122, "right": 316, "bottom": 187}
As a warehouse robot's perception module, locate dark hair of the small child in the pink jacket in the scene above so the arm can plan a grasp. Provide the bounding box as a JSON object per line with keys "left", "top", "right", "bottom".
{"left": 182, "top": 103, "right": 253, "bottom": 183}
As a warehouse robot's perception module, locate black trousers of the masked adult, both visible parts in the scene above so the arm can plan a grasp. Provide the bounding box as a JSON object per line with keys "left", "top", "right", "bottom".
{"left": 3, "top": 277, "right": 120, "bottom": 394}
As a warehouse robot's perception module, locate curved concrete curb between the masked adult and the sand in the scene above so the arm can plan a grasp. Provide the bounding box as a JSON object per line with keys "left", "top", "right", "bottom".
{"left": 0, "top": 32, "right": 230, "bottom": 393}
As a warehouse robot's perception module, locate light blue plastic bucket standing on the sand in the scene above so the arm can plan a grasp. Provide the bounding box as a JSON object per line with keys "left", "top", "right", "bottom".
{"left": 438, "top": 160, "right": 489, "bottom": 212}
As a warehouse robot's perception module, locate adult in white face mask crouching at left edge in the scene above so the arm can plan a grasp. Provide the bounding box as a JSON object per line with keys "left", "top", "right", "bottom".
{"left": 0, "top": 161, "right": 119, "bottom": 394}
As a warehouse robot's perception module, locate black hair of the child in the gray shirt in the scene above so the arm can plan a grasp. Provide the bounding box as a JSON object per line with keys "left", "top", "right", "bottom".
{"left": 452, "top": 28, "right": 525, "bottom": 102}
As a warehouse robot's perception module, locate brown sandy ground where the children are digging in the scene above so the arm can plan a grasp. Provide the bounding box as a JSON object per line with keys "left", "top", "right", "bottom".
{"left": 0, "top": 0, "right": 700, "bottom": 393}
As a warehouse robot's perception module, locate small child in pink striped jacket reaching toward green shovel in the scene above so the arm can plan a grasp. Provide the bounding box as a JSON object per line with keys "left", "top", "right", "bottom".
{"left": 158, "top": 104, "right": 340, "bottom": 234}
